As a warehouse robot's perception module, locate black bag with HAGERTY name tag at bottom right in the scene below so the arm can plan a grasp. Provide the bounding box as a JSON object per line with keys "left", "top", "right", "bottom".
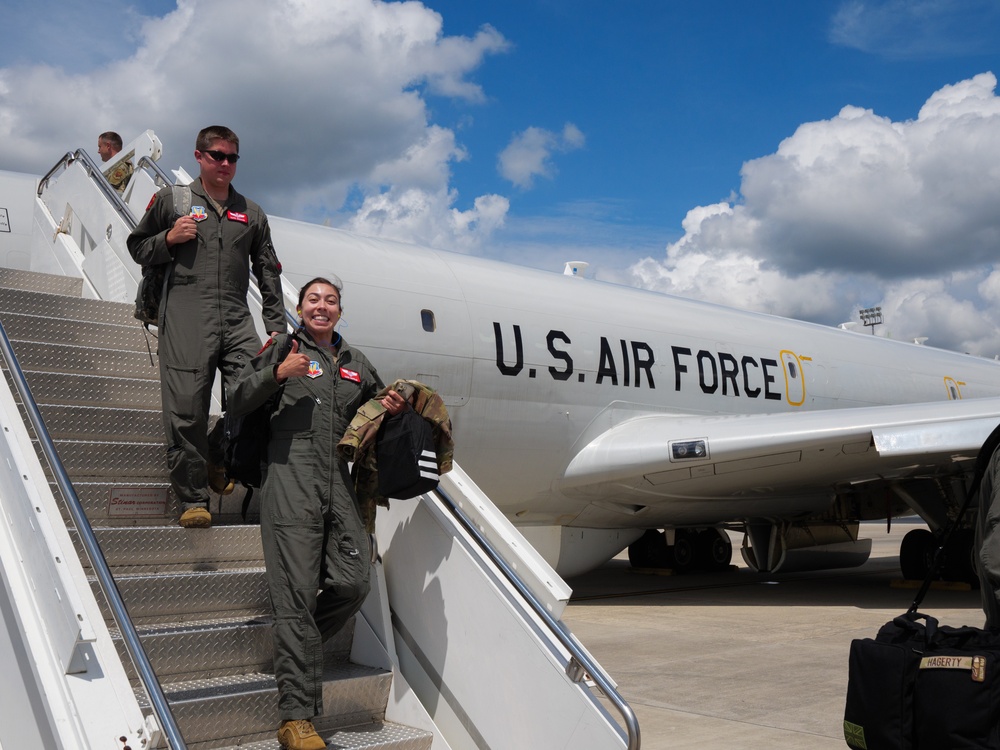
{"left": 844, "top": 612, "right": 1000, "bottom": 750}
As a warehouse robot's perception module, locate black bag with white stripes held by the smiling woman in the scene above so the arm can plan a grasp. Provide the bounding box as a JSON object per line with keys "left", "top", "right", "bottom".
{"left": 375, "top": 409, "right": 440, "bottom": 500}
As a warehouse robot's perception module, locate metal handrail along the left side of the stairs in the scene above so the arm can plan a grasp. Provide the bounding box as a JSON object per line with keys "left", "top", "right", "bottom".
{"left": 0, "top": 322, "right": 187, "bottom": 750}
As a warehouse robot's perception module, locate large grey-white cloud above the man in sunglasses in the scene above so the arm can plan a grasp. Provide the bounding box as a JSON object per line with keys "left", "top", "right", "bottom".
{"left": 0, "top": 0, "right": 509, "bottom": 254}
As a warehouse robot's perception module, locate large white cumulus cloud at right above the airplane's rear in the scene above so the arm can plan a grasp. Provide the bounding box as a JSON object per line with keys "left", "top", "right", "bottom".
{"left": 631, "top": 73, "right": 1000, "bottom": 356}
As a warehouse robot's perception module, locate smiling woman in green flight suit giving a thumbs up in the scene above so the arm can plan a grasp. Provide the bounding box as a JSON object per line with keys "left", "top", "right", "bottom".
{"left": 228, "top": 278, "right": 407, "bottom": 750}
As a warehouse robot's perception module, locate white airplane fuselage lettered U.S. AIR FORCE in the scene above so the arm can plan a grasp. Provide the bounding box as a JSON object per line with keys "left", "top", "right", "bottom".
{"left": 272, "top": 219, "right": 1000, "bottom": 528}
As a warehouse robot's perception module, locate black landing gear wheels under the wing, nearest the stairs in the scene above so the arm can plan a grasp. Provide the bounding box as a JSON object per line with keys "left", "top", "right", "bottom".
{"left": 628, "top": 529, "right": 733, "bottom": 573}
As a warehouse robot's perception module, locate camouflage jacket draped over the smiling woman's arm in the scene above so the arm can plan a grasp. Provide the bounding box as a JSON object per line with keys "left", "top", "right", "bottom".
{"left": 337, "top": 380, "right": 455, "bottom": 534}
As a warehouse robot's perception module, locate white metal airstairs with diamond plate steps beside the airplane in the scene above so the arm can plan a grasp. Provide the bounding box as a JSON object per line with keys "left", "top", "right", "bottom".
{"left": 0, "top": 134, "right": 639, "bottom": 750}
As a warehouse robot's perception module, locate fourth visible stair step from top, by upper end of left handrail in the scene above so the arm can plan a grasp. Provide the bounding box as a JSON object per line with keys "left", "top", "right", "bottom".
{"left": 11, "top": 341, "right": 160, "bottom": 381}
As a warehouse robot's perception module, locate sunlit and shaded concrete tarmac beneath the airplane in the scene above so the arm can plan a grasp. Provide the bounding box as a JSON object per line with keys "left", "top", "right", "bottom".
{"left": 563, "top": 519, "right": 984, "bottom": 750}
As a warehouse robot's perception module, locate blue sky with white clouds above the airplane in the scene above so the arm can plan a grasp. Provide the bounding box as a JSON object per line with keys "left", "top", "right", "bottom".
{"left": 0, "top": 0, "right": 1000, "bottom": 357}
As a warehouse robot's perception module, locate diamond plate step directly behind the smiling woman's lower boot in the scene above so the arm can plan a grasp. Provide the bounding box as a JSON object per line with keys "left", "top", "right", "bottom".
{"left": 146, "top": 662, "right": 392, "bottom": 748}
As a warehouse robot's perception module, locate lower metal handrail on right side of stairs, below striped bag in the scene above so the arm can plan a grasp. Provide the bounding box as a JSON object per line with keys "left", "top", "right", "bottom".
{"left": 434, "top": 486, "right": 640, "bottom": 750}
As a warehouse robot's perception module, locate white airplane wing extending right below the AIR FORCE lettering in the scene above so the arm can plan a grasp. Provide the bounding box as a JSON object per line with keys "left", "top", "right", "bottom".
{"left": 560, "top": 398, "right": 1000, "bottom": 522}
